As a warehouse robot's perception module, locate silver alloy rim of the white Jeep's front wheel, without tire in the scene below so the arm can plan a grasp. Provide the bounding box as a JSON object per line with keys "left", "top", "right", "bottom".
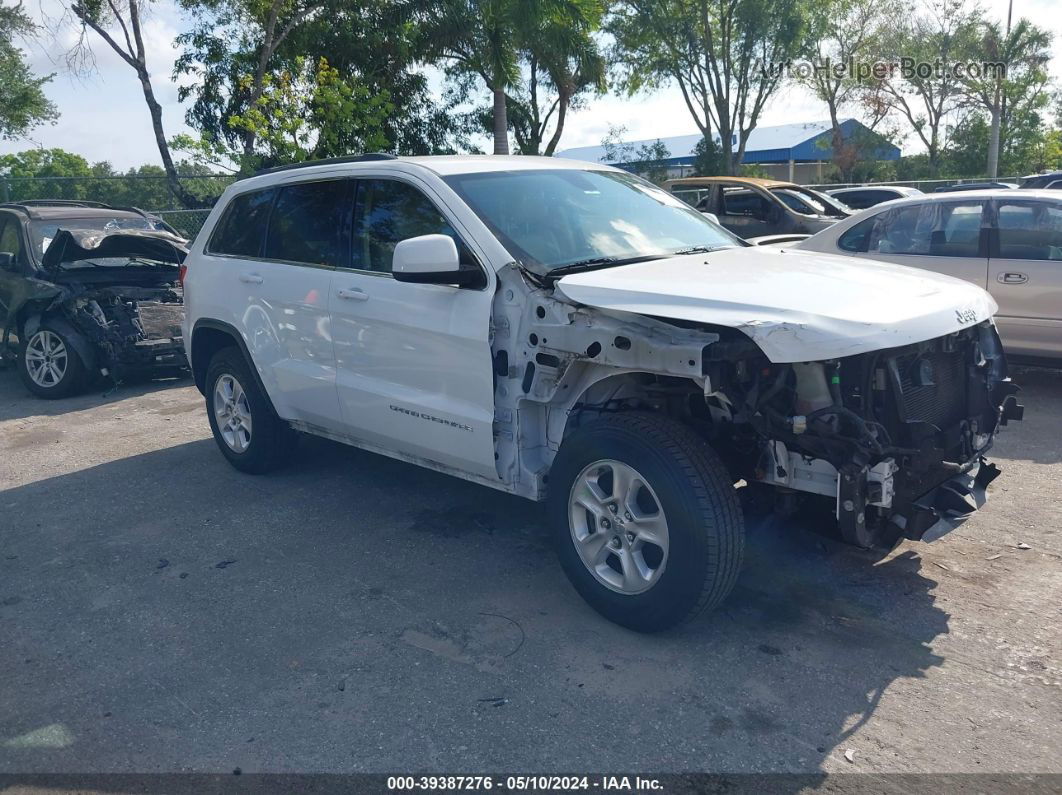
{"left": 568, "top": 459, "right": 669, "bottom": 595}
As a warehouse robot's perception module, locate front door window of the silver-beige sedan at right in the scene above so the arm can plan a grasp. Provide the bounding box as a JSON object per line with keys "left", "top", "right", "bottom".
{"left": 867, "top": 202, "right": 982, "bottom": 257}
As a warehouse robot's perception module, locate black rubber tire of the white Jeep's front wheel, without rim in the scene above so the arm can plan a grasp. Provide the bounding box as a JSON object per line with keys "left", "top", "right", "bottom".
{"left": 548, "top": 412, "right": 744, "bottom": 633}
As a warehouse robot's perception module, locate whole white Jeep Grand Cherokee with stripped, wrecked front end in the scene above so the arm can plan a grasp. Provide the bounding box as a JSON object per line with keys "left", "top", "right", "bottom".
{"left": 184, "top": 155, "right": 1021, "bottom": 630}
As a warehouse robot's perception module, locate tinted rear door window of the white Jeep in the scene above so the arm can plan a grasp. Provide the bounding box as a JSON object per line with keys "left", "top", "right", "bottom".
{"left": 262, "top": 179, "right": 354, "bottom": 267}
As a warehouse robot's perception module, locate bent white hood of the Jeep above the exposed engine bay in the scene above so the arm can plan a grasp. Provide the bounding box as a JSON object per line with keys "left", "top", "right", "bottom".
{"left": 556, "top": 247, "right": 998, "bottom": 363}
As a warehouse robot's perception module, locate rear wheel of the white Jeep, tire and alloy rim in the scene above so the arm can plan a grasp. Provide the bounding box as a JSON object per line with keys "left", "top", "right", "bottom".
{"left": 206, "top": 347, "right": 295, "bottom": 474}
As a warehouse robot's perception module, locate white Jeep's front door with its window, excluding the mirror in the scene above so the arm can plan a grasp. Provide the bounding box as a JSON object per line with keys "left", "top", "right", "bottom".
{"left": 331, "top": 176, "right": 498, "bottom": 480}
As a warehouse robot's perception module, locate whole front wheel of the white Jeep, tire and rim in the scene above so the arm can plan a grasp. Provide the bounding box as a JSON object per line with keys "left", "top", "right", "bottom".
{"left": 549, "top": 412, "right": 744, "bottom": 632}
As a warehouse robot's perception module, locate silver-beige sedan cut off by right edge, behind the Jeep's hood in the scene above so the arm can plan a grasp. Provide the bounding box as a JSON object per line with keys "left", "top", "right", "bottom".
{"left": 791, "top": 190, "right": 1062, "bottom": 360}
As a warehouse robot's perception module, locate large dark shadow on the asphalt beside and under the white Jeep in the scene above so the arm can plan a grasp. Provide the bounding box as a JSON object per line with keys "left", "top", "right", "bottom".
{"left": 0, "top": 428, "right": 948, "bottom": 776}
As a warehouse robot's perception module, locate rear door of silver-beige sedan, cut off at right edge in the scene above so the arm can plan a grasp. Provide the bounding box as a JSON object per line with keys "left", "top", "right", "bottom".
{"left": 989, "top": 198, "right": 1062, "bottom": 357}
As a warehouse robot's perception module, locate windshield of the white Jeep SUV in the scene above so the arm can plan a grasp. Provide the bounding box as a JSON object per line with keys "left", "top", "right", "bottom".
{"left": 446, "top": 169, "right": 743, "bottom": 272}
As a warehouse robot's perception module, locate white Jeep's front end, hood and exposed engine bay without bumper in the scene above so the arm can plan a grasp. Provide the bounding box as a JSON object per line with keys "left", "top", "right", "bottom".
{"left": 556, "top": 248, "right": 1022, "bottom": 547}
